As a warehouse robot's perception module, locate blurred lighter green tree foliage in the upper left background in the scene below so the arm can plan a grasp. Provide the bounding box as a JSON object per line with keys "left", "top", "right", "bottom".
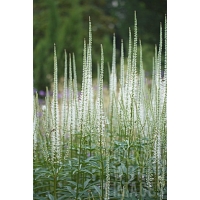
{"left": 33, "top": 0, "right": 113, "bottom": 90}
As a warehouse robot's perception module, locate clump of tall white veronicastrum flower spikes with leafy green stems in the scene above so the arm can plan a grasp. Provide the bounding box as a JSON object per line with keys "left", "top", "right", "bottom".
{"left": 33, "top": 13, "right": 167, "bottom": 200}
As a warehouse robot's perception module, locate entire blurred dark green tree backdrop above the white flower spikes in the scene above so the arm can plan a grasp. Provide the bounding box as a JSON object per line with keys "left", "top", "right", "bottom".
{"left": 33, "top": 0, "right": 167, "bottom": 91}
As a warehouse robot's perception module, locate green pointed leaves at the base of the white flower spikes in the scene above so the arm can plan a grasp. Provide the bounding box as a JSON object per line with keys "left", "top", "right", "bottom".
{"left": 33, "top": 138, "right": 166, "bottom": 200}
